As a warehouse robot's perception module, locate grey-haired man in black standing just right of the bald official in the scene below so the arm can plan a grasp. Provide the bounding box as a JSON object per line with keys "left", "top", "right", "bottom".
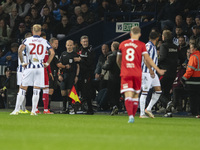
{"left": 79, "top": 35, "right": 95, "bottom": 115}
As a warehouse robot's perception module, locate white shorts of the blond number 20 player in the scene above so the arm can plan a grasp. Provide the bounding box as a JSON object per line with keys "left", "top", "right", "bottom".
{"left": 22, "top": 68, "right": 45, "bottom": 88}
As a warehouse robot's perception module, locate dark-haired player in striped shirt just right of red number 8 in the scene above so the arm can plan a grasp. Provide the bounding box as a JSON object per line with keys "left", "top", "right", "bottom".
{"left": 140, "top": 32, "right": 162, "bottom": 118}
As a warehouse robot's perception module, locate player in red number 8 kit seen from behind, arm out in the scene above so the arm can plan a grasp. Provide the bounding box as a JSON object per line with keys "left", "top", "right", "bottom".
{"left": 117, "top": 27, "right": 165, "bottom": 123}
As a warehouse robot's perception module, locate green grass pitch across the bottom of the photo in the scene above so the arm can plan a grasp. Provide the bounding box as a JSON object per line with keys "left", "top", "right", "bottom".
{"left": 0, "top": 111, "right": 200, "bottom": 150}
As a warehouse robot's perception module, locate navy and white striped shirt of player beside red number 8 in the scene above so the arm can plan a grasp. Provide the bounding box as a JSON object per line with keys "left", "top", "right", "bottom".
{"left": 142, "top": 41, "right": 158, "bottom": 73}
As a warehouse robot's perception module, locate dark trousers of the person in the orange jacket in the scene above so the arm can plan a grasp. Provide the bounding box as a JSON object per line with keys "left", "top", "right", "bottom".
{"left": 188, "top": 89, "right": 200, "bottom": 116}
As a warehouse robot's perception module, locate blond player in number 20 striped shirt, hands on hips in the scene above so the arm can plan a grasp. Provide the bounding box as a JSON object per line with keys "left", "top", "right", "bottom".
{"left": 11, "top": 24, "right": 55, "bottom": 115}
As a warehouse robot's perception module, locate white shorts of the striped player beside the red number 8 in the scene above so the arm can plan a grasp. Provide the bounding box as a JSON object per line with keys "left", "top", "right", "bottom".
{"left": 142, "top": 73, "right": 160, "bottom": 91}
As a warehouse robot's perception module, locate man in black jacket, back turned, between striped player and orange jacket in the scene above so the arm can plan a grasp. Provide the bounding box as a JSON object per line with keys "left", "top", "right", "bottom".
{"left": 158, "top": 30, "right": 178, "bottom": 112}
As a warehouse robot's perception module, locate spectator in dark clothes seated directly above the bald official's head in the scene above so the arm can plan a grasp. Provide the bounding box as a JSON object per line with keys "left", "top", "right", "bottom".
{"left": 54, "top": 16, "right": 71, "bottom": 39}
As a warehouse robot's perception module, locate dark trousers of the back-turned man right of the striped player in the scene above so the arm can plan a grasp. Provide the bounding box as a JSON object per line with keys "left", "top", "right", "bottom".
{"left": 159, "top": 75, "right": 176, "bottom": 108}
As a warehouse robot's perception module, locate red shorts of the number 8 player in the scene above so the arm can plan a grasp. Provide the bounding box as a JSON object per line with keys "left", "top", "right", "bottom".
{"left": 121, "top": 76, "right": 142, "bottom": 93}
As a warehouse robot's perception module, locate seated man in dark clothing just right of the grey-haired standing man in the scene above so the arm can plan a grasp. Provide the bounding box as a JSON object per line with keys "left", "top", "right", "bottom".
{"left": 94, "top": 44, "right": 109, "bottom": 90}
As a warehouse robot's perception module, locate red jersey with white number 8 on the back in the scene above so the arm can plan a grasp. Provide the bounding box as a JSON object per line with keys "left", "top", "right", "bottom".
{"left": 119, "top": 39, "right": 147, "bottom": 76}
